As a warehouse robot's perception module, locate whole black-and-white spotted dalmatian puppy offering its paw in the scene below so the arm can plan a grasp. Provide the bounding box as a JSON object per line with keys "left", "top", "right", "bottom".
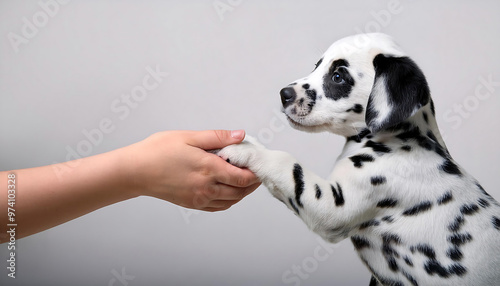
{"left": 218, "top": 33, "right": 500, "bottom": 286}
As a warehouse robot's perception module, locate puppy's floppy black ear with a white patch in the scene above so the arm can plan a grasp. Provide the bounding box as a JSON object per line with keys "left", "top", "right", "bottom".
{"left": 365, "top": 54, "right": 430, "bottom": 133}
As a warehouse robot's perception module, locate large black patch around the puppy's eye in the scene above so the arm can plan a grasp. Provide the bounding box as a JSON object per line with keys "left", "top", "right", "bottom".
{"left": 323, "top": 59, "right": 354, "bottom": 100}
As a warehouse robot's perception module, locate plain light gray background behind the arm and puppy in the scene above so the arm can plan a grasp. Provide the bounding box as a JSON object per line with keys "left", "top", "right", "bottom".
{"left": 0, "top": 0, "right": 500, "bottom": 285}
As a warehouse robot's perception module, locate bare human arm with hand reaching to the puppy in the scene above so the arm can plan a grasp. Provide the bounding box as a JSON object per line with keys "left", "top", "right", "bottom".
{"left": 0, "top": 130, "right": 260, "bottom": 243}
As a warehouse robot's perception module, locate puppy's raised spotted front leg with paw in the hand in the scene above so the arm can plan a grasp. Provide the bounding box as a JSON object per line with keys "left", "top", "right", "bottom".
{"left": 218, "top": 136, "right": 352, "bottom": 242}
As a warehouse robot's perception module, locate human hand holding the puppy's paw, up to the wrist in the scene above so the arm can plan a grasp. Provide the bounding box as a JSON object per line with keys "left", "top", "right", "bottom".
{"left": 123, "top": 130, "right": 260, "bottom": 211}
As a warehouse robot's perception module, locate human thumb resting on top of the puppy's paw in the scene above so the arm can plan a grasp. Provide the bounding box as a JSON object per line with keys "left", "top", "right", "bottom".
{"left": 186, "top": 130, "right": 245, "bottom": 150}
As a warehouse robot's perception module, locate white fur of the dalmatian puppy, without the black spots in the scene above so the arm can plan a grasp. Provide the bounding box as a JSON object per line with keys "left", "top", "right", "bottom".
{"left": 218, "top": 34, "right": 500, "bottom": 286}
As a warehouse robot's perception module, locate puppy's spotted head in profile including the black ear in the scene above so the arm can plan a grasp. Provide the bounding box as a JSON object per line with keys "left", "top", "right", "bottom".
{"left": 280, "top": 33, "right": 430, "bottom": 136}
